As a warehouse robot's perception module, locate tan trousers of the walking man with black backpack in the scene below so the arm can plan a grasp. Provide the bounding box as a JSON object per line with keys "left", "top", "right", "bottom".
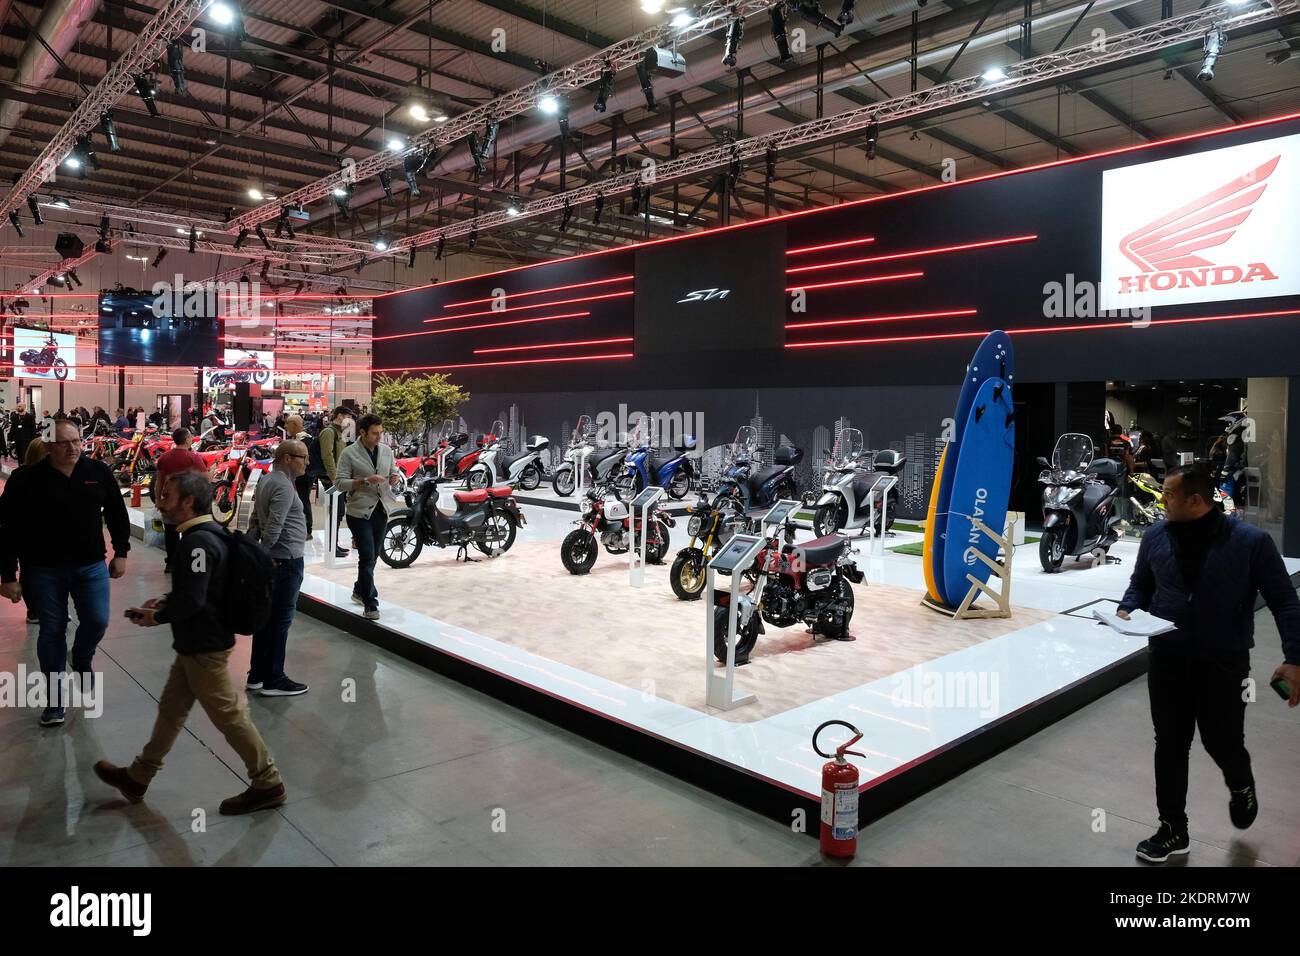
{"left": 127, "top": 650, "right": 282, "bottom": 790}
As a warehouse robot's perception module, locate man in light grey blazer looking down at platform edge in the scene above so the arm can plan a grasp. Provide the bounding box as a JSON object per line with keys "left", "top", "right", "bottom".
{"left": 335, "top": 415, "right": 402, "bottom": 620}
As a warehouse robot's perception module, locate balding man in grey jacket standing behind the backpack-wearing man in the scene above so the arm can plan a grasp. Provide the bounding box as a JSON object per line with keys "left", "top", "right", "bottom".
{"left": 246, "top": 440, "right": 307, "bottom": 697}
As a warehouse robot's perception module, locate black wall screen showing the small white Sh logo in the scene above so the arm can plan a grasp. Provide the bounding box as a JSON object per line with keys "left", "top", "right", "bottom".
{"left": 636, "top": 228, "right": 785, "bottom": 354}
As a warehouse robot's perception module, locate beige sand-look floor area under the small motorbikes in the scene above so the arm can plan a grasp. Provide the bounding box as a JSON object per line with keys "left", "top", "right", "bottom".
{"left": 308, "top": 541, "right": 1052, "bottom": 723}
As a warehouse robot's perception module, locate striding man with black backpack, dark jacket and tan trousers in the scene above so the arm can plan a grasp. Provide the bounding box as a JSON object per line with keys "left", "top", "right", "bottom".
{"left": 95, "top": 471, "right": 285, "bottom": 816}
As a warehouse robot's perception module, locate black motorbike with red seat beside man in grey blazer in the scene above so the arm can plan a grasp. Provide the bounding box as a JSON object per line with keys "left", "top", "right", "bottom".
{"left": 380, "top": 477, "right": 525, "bottom": 567}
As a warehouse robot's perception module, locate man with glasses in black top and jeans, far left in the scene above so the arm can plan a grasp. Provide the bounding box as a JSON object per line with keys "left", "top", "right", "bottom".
{"left": 0, "top": 419, "right": 131, "bottom": 727}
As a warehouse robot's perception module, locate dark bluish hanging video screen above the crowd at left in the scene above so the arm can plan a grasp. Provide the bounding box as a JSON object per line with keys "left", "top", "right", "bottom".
{"left": 99, "top": 291, "right": 220, "bottom": 368}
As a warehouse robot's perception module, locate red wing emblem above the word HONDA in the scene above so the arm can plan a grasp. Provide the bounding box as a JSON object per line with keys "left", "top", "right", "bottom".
{"left": 1119, "top": 155, "right": 1282, "bottom": 272}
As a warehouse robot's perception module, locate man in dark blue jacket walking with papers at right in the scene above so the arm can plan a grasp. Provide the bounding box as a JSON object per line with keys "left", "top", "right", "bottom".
{"left": 1119, "top": 466, "right": 1300, "bottom": 862}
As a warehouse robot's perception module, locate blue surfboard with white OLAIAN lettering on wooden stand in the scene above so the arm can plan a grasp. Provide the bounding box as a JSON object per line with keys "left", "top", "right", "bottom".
{"left": 941, "top": 377, "right": 1015, "bottom": 607}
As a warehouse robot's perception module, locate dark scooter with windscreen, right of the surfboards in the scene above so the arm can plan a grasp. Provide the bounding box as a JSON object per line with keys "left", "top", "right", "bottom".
{"left": 1039, "top": 434, "right": 1125, "bottom": 574}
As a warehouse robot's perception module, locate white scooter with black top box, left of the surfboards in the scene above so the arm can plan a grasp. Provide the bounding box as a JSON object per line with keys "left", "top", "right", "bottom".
{"left": 809, "top": 428, "right": 907, "bottom": 537}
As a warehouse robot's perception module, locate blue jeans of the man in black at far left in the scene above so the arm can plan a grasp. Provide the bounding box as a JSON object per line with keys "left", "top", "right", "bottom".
{"left": 22, "top": 561, "right": 108, "bottom": 704}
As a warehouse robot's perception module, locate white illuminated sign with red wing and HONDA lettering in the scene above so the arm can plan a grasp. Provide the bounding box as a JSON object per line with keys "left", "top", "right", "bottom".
{"left": 1101, "top": 135, "right": 1300, "bottom": 311}
